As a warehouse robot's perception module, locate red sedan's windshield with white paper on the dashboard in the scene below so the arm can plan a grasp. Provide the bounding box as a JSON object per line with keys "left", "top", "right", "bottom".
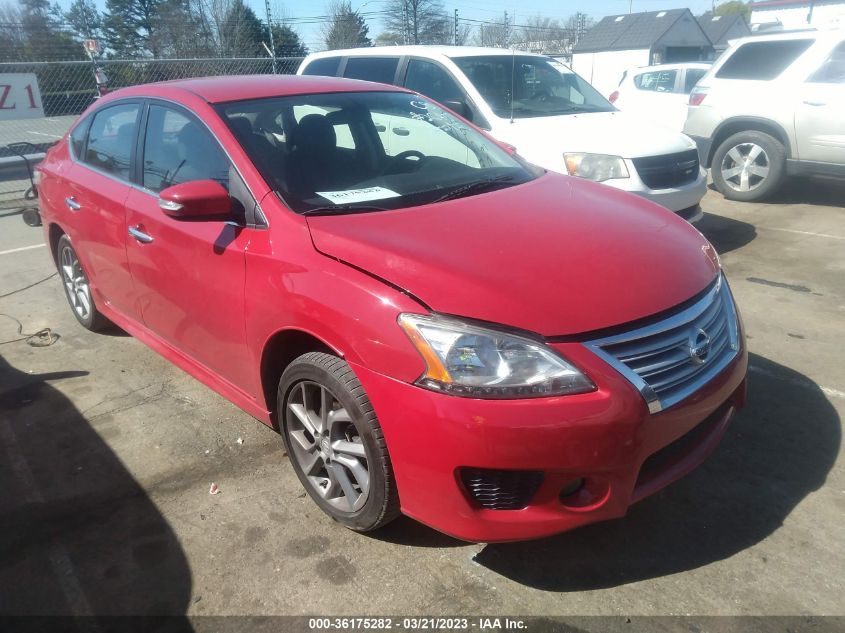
{"left": 218, "top": 92, "right": 536, "bottom": 213}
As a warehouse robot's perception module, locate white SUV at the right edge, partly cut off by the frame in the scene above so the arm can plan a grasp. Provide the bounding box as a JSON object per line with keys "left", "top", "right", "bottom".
{"left": 684, "top": 30, "right": 845, "bottom": 201}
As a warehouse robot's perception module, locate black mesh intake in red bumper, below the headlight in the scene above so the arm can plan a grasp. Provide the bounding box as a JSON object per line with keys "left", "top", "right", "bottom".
{"left": 460, "top": 468, "right": 543, "bottom": 510}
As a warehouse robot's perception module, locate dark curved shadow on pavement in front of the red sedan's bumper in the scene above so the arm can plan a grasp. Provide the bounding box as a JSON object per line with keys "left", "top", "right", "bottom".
{"left": 475, "top": 354, "right": 841, "bottom": 592}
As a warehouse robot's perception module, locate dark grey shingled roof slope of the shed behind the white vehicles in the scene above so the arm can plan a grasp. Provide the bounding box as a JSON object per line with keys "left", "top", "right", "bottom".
{"left": 572, "top": 9, "right": 692, "bottom": 53}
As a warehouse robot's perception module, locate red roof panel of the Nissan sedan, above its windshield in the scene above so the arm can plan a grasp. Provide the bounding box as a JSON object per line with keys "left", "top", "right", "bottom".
{"left": 109, "top": 75, "right": 406, "bottom": 103}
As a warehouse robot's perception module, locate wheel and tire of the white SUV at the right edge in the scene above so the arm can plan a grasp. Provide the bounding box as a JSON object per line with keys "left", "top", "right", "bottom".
{"left": 710, "top": 131, "right": 786, "bottom": 202}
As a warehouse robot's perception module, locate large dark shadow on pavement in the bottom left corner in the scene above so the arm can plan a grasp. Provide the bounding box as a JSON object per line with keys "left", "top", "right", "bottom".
{"left": 0, "top": 356, "right": 192, "bottom": 631}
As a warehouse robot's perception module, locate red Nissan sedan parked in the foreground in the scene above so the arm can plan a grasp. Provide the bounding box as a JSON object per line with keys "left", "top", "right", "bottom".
{"left": 34, "top": 76, "right": 747, "bottom": 541}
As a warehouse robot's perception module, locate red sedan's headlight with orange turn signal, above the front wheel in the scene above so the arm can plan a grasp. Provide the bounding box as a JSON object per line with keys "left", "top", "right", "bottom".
{"left": 399, "top": 314, "right": 596, "bottom": 398}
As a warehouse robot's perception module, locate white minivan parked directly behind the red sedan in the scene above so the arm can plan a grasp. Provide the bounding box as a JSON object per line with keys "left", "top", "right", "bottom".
{"left": 297, "top": 46, "right": 707, "bottom": 221}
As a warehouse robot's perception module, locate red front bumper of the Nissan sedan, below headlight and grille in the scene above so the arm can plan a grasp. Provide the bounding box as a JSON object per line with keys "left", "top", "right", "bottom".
{"left": 352, "top": 343, "right": 748, "bottom": 542}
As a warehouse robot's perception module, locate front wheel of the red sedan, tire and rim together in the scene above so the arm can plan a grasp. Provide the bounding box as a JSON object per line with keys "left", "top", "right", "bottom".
{"left": 278, "top": 352, "right": 399, "bottom": 532}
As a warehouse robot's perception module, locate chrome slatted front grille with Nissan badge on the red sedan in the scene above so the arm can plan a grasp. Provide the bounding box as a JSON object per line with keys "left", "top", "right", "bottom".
{"left": 585, "top": 276, "right": 739, "bottom": 413}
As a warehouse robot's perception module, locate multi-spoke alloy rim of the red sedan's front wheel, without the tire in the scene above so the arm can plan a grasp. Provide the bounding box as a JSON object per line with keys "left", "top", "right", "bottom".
{"left": 287, "top": 380, "right": 370, "bottom": 512}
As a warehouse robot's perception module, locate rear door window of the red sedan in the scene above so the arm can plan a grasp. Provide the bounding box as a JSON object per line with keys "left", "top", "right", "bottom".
{"left": 82, "top": 103, "right": 141, "bottom": 180}
